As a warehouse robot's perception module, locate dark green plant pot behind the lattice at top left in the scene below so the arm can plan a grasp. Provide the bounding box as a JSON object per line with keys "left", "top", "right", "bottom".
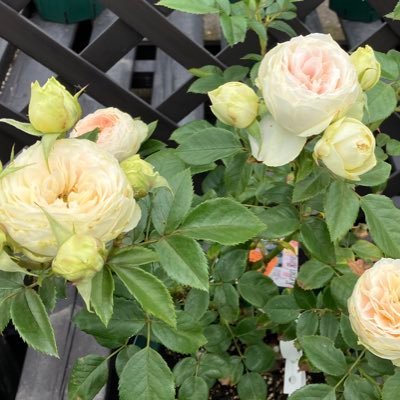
{"left": 34, "top": 0, "right": 104, "bottom": 24}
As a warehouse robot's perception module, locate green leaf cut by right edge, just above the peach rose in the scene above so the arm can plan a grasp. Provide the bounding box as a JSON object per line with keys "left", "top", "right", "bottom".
{"left": 361, "top": 194, "right": 400, "bottom": 258}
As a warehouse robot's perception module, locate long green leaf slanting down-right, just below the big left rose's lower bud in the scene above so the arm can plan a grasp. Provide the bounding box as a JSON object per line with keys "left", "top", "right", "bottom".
{"left": 112, "top": 265, "right": 176, "bottom": 326}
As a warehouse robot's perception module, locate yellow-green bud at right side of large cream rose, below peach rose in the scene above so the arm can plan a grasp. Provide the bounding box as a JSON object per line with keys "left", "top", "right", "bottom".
{"left": 120, "top": 154, "right": 168, "bottom": 198}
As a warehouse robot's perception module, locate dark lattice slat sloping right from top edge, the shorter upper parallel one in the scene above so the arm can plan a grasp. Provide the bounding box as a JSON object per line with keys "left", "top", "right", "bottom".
{"left": 104, "top": 0, "right": 225, "bottom": 69}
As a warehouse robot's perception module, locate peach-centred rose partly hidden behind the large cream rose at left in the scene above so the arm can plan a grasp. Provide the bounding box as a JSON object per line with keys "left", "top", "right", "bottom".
{"left": 70, "top": 107, "right": 148, "bottom": 161}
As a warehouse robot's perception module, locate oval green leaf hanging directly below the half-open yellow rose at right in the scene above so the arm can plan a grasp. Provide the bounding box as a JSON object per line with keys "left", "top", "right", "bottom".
{"left": 324, "top": 181, "right": 360, "bottom": 241}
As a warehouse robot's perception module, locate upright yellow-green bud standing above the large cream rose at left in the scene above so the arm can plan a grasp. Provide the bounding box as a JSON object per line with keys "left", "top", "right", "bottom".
{"left": 29, "top": 77, "right": 82, "bottom": 133}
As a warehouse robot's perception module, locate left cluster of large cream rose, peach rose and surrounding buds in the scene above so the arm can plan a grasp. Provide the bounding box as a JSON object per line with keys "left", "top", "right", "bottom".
{"left": 0, "top": 78, "right": 162, "bottom": 282}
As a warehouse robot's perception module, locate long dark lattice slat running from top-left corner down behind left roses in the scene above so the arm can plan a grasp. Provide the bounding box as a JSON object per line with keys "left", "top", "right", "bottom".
{"left": 0, "top": 2, "right": 176, "bottom": 135}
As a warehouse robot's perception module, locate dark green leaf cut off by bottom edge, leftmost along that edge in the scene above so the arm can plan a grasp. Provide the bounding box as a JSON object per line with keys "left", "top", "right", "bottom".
{"left": 68, "top": 355, "right": 108, "bottom": 400}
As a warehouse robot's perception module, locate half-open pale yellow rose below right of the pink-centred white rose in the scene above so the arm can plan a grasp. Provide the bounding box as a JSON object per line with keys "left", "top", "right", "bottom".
{"left": 314, "top": 118, "right": 376, "bottom": 181}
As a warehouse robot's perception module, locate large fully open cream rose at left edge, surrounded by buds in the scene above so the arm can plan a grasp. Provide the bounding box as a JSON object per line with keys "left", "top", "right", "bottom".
{"left": 0, "top": 139, "right": 140, "bottom": 257}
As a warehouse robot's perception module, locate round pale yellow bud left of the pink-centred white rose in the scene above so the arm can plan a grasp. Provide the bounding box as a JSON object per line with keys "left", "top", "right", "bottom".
{"left": 208, "top": 82, "right": 259, "bottom": 128}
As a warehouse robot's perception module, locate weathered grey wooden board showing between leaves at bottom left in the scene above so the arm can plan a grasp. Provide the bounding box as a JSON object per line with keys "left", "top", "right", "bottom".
{"left": 16, "top": 288, "right": 109, "bottom": 400}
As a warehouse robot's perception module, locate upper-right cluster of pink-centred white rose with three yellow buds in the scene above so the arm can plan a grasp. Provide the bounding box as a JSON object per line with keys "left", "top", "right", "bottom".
{"left": 209, "top": 34, "right": 380, "bottom": 181}
